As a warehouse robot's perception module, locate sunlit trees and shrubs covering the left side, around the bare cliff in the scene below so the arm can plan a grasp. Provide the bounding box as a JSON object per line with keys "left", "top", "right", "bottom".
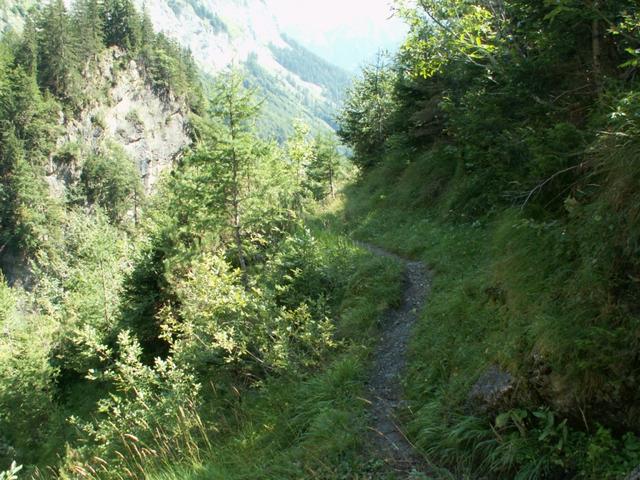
{"left": 0, "top": 0, "right": 361, "bottom": 478}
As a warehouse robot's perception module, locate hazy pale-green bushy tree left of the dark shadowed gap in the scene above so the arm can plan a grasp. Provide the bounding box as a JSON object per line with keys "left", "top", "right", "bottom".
{"left": 50, "top": 211, "right": 132, "bottom": 375}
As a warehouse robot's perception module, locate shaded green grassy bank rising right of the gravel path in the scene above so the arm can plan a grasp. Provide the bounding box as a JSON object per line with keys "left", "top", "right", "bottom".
{"left": 330, "top": 151, "right": 640, "bottom": 480}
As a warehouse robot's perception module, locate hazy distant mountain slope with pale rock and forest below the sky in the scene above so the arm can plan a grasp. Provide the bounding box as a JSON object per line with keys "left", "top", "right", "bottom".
{"left": 136, "top": 0, "right": 349, "bottom": 139}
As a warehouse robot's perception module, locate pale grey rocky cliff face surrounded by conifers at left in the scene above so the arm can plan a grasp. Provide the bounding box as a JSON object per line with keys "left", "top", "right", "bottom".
{"left": 48, "top": 48, "right": 191, "bottom": 196}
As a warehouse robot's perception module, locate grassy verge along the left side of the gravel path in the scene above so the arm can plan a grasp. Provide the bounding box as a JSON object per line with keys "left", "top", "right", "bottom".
{"left": 149, "top": 218, "right": 402, "bottom": 480}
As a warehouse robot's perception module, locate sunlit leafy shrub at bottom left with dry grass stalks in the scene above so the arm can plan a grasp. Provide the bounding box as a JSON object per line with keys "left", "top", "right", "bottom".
{"left": 65, "top": 331, "right": 208, "bottom": 478}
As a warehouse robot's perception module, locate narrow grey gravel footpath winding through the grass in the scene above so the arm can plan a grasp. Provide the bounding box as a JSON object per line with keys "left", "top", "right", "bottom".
{"left": 361, "top": 243, "right": 431, "bottom": 478}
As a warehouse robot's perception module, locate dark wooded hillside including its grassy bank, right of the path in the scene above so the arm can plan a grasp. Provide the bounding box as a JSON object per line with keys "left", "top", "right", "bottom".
{"left": 340, "top": 0, "right": 640, "bottom": 479}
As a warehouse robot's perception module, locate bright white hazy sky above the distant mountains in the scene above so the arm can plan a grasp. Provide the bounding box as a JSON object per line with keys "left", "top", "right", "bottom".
{"left": 269, "top": 0, "right": 406, "bottom": 71}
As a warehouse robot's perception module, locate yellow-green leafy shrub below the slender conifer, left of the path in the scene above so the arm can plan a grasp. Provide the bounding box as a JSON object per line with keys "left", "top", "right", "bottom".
{"left": 163, "top": 254, "right": 332, "bottom": 371}
